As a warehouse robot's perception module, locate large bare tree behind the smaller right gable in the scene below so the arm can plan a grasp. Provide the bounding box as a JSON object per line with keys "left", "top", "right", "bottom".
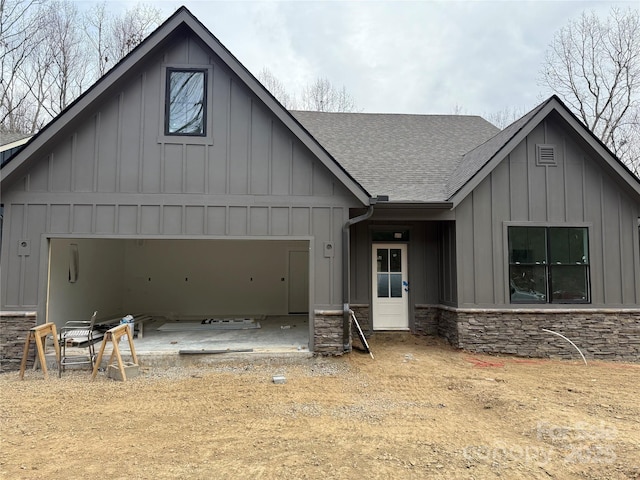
{"left": 540, "top": 8, "right": 640, "bottom": 174}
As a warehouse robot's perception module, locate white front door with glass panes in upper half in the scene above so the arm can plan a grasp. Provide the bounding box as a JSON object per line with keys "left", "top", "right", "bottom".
{"left": 371, "top": 244, "right": 409, "bottom": 330}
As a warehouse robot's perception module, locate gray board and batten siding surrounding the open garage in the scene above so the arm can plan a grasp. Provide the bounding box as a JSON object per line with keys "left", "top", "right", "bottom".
{"left": 2, "top": 11, "right": 368, "bottom": 352}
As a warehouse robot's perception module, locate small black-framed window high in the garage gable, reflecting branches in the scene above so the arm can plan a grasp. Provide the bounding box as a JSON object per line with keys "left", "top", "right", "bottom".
{"left": 165, "top": 68, "right": 207, "bottom": 136}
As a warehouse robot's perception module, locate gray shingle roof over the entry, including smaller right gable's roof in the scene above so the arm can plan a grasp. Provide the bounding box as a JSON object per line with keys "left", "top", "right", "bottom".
{"left": 292, "top": 95, "right": 640, "bottom": 207}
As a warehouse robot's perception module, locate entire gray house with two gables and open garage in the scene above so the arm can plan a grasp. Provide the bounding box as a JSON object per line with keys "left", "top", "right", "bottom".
{"left": 0, "top": 8, "right": 640, "bottom": 365}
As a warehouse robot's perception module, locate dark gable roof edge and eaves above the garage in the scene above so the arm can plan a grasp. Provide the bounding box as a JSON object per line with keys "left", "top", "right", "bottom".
{"left": 0, "top": 7, "right": 371, "bottom": 205}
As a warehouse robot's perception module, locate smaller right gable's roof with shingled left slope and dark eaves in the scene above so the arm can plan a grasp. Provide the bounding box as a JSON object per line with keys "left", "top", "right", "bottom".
{"left": 447, "top": 95, "right": 640, "bottom": 207}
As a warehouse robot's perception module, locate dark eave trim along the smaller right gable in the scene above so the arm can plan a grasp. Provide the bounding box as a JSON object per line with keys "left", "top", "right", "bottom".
{"left": 449, "top": 96, "right": 640, "bottom": 208}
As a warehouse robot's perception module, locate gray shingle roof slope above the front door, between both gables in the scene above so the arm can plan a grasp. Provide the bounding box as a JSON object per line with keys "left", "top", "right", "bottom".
{"left": 291, "top": 111, "right": 499, "bottom": 202}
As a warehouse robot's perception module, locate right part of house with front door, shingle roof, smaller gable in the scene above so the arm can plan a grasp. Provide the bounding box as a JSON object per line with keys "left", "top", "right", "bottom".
{"left": 296, "top": 104, "right": 640, "bottom": 361}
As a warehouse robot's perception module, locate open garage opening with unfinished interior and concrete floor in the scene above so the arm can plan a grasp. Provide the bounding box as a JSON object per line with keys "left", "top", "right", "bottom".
{"left": 47, "top": 238, "right": 313, "bottom": 353}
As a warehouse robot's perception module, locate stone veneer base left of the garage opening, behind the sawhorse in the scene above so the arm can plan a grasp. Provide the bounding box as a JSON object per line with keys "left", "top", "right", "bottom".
{"left": 0, "top": 312, "right": 37, "bottom": 372}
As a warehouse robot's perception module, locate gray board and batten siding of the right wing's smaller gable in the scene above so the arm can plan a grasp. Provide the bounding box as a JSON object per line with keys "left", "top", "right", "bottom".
{"left": 455, "top": 115, "right": 640, "bottom": 308}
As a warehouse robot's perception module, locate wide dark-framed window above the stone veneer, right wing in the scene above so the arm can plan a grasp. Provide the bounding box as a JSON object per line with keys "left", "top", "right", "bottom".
{"left": 509, "top": 227, "right": 590, "bottom": 303}
